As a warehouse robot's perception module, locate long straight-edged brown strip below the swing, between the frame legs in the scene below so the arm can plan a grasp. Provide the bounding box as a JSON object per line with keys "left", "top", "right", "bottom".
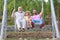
{"left": 7, "top": 32, "right": 52, "bottom": 38}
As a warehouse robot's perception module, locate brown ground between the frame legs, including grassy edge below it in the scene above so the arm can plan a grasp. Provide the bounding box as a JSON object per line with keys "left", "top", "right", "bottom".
{"left": 5, "top": 32, "right": 52, "bottom": 40}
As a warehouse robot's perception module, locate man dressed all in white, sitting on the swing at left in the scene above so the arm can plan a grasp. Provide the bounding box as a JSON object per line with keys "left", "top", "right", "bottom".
{"left": 12, "top": 7, "right": 26, "bottom": 31}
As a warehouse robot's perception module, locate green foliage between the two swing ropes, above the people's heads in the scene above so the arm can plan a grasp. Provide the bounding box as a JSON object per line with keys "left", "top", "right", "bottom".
{"left": 15, "top": 0, "right": 41, "bottom": 12}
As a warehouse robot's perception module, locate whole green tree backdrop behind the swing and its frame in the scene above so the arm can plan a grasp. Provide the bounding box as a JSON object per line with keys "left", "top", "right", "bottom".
{"left": 0, "top": 0, "right": 60, "bottom": 39}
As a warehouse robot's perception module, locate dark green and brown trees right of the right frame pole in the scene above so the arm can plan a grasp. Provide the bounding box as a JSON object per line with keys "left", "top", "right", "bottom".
{"left": 54, "top": 0, "right": 60, "bottom": 31}
